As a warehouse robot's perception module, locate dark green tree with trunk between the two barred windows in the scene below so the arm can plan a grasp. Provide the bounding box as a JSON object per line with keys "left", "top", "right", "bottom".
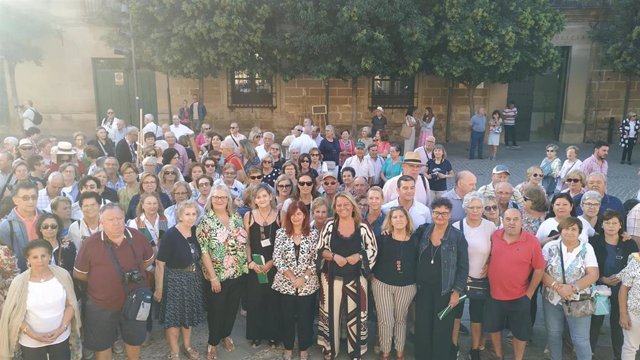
{"left": 280, "top": 0, "right": 434, "bottom": 131}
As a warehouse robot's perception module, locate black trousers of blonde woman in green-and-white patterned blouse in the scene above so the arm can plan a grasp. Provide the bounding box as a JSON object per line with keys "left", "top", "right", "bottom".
{"left": 207, "top": 276, "right": 245, "bottom": 345}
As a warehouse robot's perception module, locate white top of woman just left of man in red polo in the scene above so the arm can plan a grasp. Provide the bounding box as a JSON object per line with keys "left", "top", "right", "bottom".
{"left": 452, "top": 218, "right": 498, "bottom": 279}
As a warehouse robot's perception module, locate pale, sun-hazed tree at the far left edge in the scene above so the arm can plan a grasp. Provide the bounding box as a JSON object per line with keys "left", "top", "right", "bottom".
{"left": 0, "top": 1, "right": 57, "bottom": 127}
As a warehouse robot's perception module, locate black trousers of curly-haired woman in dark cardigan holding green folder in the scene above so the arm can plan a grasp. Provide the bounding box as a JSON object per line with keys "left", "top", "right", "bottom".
{"left": 415, "top": 286, "right": 455, "bottom": 360}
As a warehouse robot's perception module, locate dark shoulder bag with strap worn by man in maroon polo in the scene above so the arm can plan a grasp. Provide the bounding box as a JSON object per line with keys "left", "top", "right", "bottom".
{"left": 107, "top": 230, "right": 153, "bottom": 321}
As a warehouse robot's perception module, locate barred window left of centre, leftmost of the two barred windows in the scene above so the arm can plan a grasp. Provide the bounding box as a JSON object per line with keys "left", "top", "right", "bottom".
{"left": 229, "top": 70, "right": 276, "bottom": 108}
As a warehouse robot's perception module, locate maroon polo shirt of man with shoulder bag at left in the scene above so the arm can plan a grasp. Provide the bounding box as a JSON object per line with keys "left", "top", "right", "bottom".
{"left": 74, "top": 228, "right": 153, "bottom": 310}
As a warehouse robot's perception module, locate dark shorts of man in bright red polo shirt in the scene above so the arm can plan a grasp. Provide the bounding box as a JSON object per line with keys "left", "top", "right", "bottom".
{"left": 483, "top": 295, "right": 533, "bottom": 341}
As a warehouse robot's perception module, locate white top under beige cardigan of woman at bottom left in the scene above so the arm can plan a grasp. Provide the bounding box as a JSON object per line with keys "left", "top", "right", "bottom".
{"left": 18, "top": 277, "right": 71, "bottom": 348}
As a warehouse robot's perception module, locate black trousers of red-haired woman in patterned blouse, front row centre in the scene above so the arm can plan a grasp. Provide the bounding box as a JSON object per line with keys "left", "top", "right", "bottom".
{"left": 281, "top": 294, "right": 317, "bottom": 351}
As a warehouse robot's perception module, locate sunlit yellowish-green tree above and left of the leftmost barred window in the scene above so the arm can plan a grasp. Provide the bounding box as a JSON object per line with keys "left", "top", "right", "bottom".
{"left": 106, "top": 0, "right": 270, "bottom": 96}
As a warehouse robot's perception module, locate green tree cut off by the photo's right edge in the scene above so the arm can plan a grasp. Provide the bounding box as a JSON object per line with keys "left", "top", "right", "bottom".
{"left": 591, "top": 0, "right": 640, "bottom": 117}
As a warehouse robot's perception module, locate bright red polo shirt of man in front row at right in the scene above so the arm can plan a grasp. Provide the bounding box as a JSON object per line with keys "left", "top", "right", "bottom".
{"left": 489, "top": 229, "right": 546, "bottom": 300}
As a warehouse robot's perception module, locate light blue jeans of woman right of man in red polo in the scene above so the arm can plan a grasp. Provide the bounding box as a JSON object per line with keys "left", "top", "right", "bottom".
{"left": 542, "top": 299, "right": 591, "bottom": 360}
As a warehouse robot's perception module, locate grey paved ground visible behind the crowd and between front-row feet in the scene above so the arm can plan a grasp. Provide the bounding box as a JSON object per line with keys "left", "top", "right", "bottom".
{"left": 142, "top": 143, "right": 640, "bottom": 360}
